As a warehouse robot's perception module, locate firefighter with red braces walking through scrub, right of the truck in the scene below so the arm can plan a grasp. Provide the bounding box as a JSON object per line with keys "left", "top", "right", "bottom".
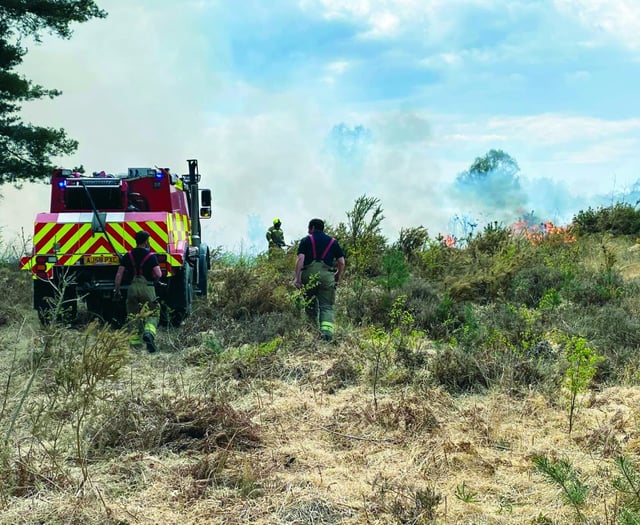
{"left": 294, "top": 219, "right": 345, "bottom": 341}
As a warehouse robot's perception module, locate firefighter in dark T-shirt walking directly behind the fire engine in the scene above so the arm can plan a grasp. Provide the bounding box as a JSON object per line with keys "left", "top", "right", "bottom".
{"left": 113, "top": 231, "right": 162, "bottom": 353}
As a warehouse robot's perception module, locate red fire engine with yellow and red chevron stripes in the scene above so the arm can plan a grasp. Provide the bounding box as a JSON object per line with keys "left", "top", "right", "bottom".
{"left": 20, "top": 159, "right": 211, "bottom": 326}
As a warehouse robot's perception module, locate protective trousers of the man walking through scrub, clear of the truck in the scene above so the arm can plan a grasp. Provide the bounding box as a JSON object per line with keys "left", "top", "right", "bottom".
{"left": 302, "top": 261, "right": 336, "bottom": 341}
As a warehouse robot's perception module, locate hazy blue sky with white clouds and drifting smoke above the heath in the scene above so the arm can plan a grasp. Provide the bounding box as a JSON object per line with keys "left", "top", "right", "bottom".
{"left": 0, "top": 0, "right": 640, "bottom": 253}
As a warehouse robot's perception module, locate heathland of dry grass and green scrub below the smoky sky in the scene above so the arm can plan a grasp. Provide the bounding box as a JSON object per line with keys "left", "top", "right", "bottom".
{"left": 0, "top": 196, "right": 640, "bottom": 525}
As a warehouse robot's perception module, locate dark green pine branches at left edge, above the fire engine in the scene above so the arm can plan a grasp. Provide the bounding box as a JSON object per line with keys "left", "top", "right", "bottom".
{"left": 0, "top": 0, "right": 107, "bottom": 185}
